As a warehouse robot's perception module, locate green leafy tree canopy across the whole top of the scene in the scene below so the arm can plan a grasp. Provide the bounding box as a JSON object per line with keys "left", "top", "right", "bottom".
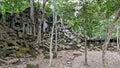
{"left": 0, "top": 0, "right": 120, "bottom": 37}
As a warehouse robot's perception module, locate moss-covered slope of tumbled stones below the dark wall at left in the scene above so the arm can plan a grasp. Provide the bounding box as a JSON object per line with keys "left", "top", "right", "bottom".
{"left": 0, "top": 18, "right": 36, "bottom": 57}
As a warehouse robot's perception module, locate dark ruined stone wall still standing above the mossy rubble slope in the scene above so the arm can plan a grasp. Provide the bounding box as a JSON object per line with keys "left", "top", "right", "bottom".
{"left": 5, "top": 7, "right": 38, "bottom": 34}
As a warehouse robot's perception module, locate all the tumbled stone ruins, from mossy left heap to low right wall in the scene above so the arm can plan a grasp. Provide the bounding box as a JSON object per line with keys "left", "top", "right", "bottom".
{"left": 0, "top": 8, "right": 116, "bottom": 57}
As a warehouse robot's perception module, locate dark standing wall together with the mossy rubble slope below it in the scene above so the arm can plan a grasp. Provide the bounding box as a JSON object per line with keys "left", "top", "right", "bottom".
{"left": 0, "top": 8, "right": 42, "bottom": 58}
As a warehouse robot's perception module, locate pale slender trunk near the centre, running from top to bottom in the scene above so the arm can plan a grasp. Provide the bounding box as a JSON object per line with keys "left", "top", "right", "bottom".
{"left": 49, "top": 0, "right": 57, "bottom": 68}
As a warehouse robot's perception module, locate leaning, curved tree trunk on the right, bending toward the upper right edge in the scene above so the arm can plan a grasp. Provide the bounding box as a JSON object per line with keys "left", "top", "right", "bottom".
{"left": 102, "top": 9, "right": 120, "bottom": 68}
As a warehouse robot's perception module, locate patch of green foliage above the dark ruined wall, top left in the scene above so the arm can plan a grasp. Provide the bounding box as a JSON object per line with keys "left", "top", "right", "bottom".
{"left": 0, "top": 0, "right": 29, "bottom": 15}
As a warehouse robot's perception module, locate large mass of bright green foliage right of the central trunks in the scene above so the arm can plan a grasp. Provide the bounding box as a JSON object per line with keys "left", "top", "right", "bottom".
{"left": 55, "top": 0, "right": 120, "bottom": 37}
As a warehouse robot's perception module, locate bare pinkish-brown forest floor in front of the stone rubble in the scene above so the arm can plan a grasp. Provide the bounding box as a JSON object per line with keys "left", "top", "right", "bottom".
{"left": 0, "top": 50, "right": 120, "bottom": 68}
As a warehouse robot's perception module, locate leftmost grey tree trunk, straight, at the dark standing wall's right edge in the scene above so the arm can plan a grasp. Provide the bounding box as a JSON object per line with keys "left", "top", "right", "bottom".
{"left": 30, "top": 0, "right": 36, "bottom": 36}
